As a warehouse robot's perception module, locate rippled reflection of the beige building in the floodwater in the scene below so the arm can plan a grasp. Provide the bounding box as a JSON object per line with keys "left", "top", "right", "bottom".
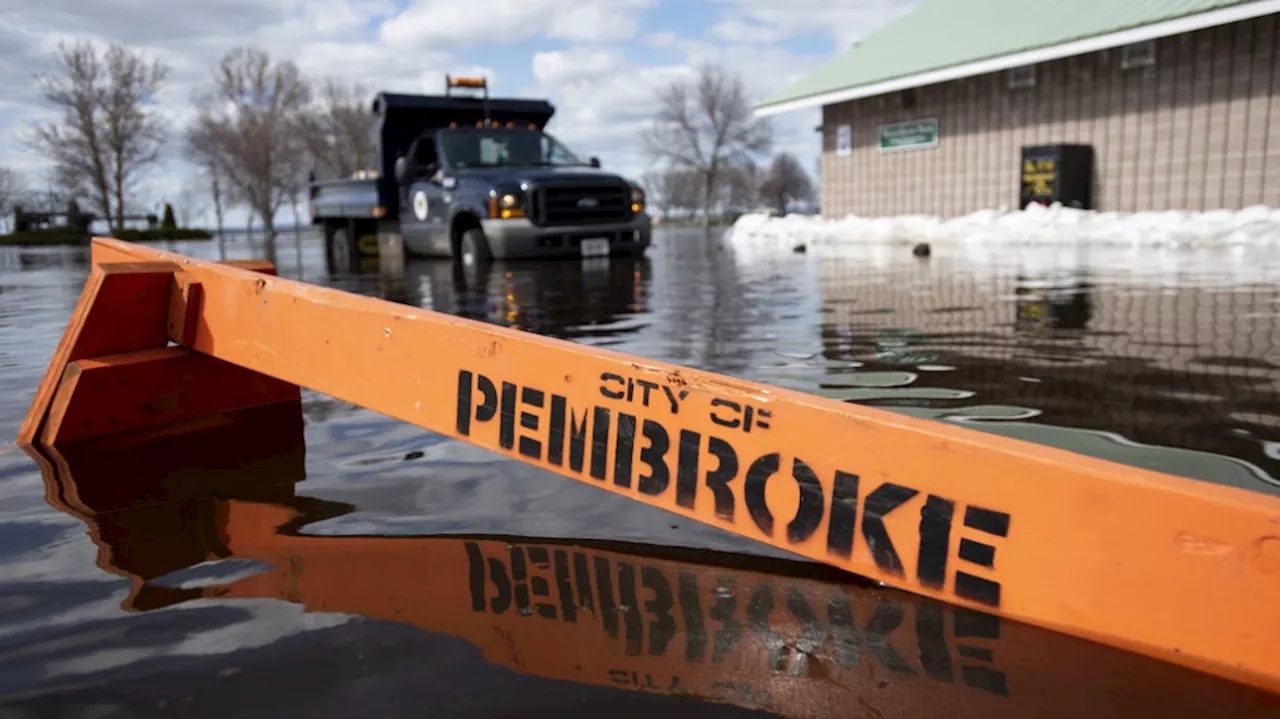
{"left": 808, "top": 245, "right": 1280, "bottom": 494}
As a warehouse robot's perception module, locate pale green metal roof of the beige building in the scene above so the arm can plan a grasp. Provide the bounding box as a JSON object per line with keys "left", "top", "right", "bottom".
{"left": 756, "top": 0, "right": 1257, "bottom": 109}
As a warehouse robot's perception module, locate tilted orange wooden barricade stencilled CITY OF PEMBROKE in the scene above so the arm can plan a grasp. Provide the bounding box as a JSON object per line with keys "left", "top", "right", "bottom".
{"left": 18, "top": 238, "right": 1280, "bottom": 691}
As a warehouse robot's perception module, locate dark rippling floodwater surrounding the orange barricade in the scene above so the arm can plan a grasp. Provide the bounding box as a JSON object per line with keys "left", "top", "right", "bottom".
{"left": 0, "top": 232, "right": 1280, "bottom": 718}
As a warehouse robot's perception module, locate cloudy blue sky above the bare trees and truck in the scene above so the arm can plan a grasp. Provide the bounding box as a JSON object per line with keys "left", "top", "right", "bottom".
{"left": 0, "top": 0, "right": 915, "bottom": 223}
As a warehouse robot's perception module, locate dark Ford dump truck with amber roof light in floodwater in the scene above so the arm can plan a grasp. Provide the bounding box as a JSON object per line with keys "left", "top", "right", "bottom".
{"left": 310, "top": 78, "right": 652, "bottom": 273}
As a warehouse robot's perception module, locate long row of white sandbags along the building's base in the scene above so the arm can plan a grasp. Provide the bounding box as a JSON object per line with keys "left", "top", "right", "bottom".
{"left": 726, "top": 205, "right": 1280, "bottom": 251}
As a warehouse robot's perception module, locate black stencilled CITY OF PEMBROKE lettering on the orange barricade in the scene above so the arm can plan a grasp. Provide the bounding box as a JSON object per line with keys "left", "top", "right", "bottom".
{"left": 456, "top": 370, "right": 1010, "bottom": 606}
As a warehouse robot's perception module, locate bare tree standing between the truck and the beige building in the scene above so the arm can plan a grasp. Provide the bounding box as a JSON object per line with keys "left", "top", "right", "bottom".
{"left": 643, "top": 64, "right": 773, "bottom": 225}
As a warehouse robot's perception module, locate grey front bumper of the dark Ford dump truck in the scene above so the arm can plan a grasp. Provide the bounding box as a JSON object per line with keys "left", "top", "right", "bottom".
{"left": 480, "top": 212, "right": 653, "bottom": 260}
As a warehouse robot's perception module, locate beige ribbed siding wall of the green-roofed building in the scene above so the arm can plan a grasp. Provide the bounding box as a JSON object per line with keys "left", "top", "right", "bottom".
{"left": 822, "top": 15, "right": 1280, "bottom": 217}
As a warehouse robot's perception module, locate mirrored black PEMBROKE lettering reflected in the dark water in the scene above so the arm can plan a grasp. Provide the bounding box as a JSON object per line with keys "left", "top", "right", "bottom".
{"left": 465, "top": 541, "right": 1009, "bottom": 704}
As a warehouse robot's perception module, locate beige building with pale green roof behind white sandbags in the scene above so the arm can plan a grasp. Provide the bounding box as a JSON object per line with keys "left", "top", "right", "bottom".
{"left": 755, "top": 0, "right": 1280, "bottom": 217}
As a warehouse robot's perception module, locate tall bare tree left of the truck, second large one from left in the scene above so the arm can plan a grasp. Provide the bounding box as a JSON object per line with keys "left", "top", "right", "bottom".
{"left": 191, "top": 47, "right": 311, "bottom": 244}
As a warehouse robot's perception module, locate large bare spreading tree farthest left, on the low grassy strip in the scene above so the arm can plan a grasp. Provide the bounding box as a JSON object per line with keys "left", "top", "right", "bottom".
{"left": 27, "top": 41, "right": 169, "bottom": 229}
